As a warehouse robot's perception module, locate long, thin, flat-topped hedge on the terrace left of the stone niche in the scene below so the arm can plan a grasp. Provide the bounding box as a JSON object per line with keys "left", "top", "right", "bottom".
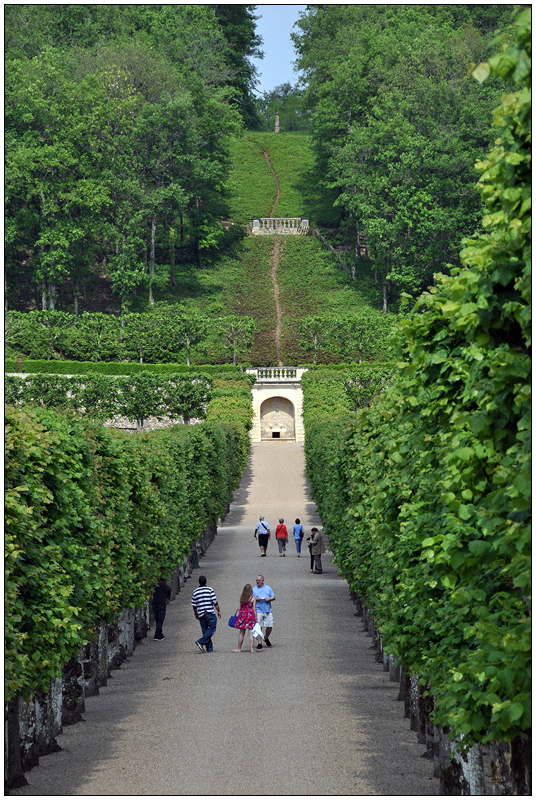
{"left": 4, "top": 358, "right": 240, "bottom": 375}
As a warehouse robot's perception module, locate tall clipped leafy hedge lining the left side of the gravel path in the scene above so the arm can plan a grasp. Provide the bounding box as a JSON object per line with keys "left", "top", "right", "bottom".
{"left": 5, "top": 376, "right": 252, "bottom": 699}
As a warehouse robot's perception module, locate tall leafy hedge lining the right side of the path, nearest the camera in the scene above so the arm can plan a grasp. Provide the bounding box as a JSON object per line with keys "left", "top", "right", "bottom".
{"left": 303, "top": 11, "right": 531, "bottom": 748}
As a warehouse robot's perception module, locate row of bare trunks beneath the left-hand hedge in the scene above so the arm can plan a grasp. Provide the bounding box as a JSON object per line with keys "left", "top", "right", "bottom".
{"left": 4, "top": 525, "right": 217, "bottom": 794}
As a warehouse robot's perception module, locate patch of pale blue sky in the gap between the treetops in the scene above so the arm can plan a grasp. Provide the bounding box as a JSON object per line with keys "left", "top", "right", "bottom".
{"left": 251, "top": 4, "right": 306, "bottom": 95}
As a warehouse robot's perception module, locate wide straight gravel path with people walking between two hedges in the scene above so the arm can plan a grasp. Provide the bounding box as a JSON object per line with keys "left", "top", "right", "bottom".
{"left": 13, "top": 441, "right": 438, "bottom": 796}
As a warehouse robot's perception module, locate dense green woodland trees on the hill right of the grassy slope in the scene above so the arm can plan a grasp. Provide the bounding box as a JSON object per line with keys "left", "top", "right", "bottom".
{"left": 292, "top": 4, "right": 513, "bottom": 304}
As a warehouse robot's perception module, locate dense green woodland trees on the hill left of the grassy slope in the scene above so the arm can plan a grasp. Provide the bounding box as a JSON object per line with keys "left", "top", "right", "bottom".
{"left": 6, "top": 5, "right": 249, "bottom": 314}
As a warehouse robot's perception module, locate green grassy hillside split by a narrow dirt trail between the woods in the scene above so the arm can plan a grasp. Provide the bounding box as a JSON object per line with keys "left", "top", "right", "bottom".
{"left": 9, "top": 132, "right": 394, "bottom": 366}
